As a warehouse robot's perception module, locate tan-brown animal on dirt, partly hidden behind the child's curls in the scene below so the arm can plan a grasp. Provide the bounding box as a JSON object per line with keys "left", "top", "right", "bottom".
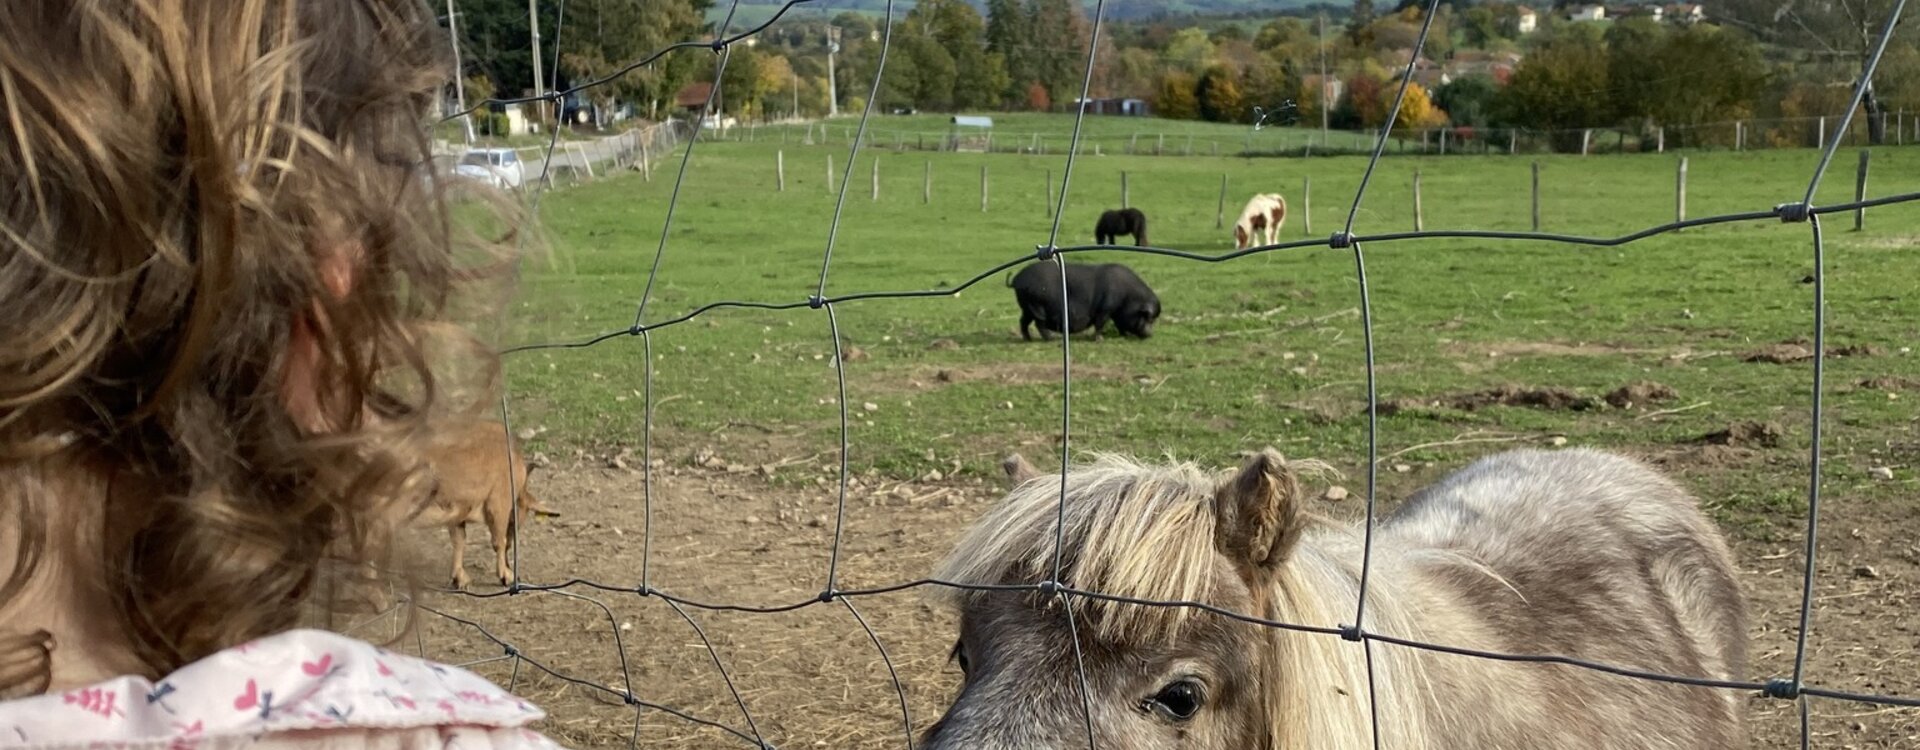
{"left": 413, "top": 420, "right": 559, "bottom": 589}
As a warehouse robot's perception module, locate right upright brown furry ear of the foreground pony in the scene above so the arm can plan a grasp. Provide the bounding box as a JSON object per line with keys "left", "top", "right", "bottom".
{"left": 1213, "top": 447, "right": 1306, "bottom": 570}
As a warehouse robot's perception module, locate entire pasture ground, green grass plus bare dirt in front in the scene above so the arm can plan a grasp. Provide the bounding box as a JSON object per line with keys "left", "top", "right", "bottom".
{"left": 428, "top": 117, "right": 1920, "bottom": 748}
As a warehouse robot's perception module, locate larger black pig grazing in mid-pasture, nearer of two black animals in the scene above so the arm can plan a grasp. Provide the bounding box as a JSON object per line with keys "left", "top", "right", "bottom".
{"left": 1006, "top": 263, "right": 1160, "bottom": 341}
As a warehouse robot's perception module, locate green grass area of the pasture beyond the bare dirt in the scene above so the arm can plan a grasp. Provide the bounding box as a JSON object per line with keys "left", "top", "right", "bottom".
{"left": 507, "top": 117, "right": 1920, "bottom": 533}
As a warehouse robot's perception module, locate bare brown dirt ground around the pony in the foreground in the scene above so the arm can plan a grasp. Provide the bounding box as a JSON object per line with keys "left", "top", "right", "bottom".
{"left": 397, "top": 454, "right": 1920, "bottom": 750}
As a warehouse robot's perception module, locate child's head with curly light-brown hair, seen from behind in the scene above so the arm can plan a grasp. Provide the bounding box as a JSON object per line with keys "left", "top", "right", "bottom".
{"left": 0, "top": 0, "right": 514, "bottom": 691}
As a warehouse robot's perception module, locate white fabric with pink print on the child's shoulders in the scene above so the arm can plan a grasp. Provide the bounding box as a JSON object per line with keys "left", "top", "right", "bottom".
{"left": 0, "top": 631, "right": 557, "bottom": 750}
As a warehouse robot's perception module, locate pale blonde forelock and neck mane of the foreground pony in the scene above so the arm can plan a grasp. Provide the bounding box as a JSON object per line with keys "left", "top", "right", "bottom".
{"left": 935, "top": 455, "right": 1434, "bottom": 748}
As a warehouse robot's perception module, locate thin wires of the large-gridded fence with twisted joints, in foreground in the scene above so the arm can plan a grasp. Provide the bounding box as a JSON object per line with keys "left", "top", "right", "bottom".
{"left": 408, "top": 0, "right": 1920, "bottom": 750}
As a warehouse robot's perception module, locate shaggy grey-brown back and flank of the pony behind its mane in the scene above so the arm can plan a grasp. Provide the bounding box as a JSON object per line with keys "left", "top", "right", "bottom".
{"left": 1377, "top": 449, "right": 1747, "bottom": 748}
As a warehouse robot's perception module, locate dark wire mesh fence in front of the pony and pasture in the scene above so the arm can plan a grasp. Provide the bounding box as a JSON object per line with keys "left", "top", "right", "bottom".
{"left": 397, "top": 0, "right": 1920, "bottom": 748}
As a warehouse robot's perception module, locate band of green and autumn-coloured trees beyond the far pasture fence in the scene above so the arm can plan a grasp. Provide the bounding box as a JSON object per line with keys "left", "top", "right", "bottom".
{"left": 441, "top": 0, "right": 1920, "bottom": 148}
